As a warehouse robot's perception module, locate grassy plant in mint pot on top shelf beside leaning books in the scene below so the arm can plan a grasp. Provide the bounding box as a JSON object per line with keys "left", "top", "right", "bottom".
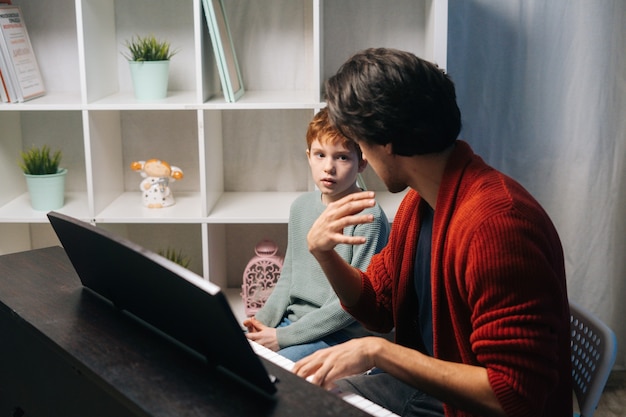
{"left": 122, "top": 35, "right": 178, "bottom": 100}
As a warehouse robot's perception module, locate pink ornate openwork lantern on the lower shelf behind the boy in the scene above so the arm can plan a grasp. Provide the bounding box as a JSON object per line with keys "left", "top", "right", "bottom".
{"left": 241, "top": 239, "right": 283, "bottom": 317}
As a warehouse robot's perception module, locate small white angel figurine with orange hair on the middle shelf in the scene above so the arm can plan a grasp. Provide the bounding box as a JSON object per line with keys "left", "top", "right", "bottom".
{"left": 130, "top": 159, "right": 183, "bottom": 208}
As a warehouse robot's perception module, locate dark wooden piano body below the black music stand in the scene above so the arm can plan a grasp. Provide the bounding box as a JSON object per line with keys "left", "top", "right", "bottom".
{"left": 0, "top": 247, "right": 368, "bottom": 417}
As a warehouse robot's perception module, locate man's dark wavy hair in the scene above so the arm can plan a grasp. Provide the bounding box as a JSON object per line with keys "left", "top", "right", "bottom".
{"left": 325, "top": 48, "right": 461, "bottom": 156}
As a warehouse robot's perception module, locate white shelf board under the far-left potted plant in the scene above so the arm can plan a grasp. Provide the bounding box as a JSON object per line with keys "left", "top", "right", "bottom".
{"left": 0, "top": 191, "right": 90, "bottom": 223}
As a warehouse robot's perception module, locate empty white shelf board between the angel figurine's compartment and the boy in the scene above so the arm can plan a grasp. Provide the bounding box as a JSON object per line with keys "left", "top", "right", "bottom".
{"left": 208, "top": 192, "right": 302, "bottom": 223}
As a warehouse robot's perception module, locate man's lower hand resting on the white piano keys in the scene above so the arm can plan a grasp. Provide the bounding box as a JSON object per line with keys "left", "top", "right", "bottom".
{"left": 293, "top": 337, "right": 387, "bottom": 389}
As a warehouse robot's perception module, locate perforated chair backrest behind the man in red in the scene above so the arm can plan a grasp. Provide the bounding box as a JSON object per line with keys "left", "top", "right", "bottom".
{"left": 569, "top": 300, "right": 617, "bottom": 417}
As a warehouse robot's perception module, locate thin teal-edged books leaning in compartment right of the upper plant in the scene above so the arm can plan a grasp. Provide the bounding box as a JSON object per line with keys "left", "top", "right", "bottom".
{"left": 202, "top": 0, "right": 244, "bottom": 103}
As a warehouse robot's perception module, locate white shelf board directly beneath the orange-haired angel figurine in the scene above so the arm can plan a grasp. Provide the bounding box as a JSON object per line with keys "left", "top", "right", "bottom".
{"left": 95, "top": 191, "right": 205, "bottom": 223}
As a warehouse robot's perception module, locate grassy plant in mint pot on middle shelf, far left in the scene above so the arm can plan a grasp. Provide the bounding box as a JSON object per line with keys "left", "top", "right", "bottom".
{"left": 19, "top": 145, "right": 67, "bottom": 211}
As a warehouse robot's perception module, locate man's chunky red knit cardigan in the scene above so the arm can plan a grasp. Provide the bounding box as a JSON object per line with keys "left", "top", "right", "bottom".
{"left": 347, "top": 141, "right": 572, "bottom": 417}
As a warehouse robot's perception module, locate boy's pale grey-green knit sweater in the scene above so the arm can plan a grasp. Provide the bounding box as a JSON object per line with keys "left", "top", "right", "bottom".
{"left": 256, "top": 191, "right": 389, "bottom": 349}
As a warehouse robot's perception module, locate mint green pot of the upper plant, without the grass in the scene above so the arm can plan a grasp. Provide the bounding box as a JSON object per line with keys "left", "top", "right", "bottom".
{"left": 128, "top": 61, "right": 170, "bottom": 101}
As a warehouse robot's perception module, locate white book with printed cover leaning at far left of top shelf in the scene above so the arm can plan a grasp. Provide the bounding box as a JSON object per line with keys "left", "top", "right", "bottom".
{"left": 0, "top": 5, "right": 46, "bottom": 102}
